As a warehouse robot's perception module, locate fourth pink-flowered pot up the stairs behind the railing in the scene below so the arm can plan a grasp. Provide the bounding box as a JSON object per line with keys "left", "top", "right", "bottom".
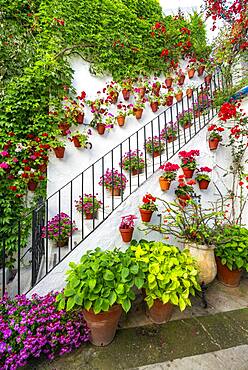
{"left": 120, "top": 150, "right": 145, "bottom": 175}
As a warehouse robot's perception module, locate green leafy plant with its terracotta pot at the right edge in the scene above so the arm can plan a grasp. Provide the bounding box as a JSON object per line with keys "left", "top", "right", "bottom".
{"left": 215, "top": 225, "right": 248, "bottom": 287}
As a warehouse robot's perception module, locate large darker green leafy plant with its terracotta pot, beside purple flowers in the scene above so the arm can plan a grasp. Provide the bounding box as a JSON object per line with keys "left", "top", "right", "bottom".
{"left": 57, "top": 248, "right": 144, "bottom": 346}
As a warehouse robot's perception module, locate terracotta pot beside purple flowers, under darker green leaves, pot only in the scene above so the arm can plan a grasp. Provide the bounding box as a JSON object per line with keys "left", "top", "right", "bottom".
{"left": 83, "top": 305, "right": 122, "bottom": 346}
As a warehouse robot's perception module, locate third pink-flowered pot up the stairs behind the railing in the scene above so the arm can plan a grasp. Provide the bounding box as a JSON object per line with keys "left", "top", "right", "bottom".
{"left": 99, "top": 168, "right": 127, "bottom": 196}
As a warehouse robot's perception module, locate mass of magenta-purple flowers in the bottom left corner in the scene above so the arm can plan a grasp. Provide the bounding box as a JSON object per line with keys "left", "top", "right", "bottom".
{"left": 0, "top": 293, "right": 89, "bottom": 370}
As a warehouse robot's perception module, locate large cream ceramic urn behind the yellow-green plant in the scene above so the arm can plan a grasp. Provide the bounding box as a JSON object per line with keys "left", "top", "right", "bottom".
{"left": 185, "top": 242, "right": 217, "bottom": 284}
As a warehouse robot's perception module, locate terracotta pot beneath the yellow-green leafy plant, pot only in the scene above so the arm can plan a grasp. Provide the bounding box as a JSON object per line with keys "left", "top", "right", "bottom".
{"left": 146, "top": 299, "right": 173, "bottom": 324}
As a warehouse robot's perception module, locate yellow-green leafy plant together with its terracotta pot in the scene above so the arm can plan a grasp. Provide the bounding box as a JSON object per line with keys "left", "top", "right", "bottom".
{"left": 129, "top": 240, "right": 201, "bottom": 324}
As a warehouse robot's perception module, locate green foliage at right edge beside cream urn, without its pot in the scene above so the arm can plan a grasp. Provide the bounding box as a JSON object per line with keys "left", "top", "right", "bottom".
{"left": 215, "top": 225, "right": 248, "bottom": 271}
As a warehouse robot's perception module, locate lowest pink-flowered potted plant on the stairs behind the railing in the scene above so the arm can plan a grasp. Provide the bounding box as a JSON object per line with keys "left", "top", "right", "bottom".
{"left": 42, "top": 212, "right": 78, "bottom": 248}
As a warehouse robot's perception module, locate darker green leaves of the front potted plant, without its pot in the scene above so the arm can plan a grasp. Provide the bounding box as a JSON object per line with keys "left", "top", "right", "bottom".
{"left": 57, "top": 248, "right": 144, "bottom": 314}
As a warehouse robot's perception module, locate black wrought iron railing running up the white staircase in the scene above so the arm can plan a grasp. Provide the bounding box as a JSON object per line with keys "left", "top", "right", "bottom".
{"left": 0, "top": 72, "right": 230, "bottom": 295}
